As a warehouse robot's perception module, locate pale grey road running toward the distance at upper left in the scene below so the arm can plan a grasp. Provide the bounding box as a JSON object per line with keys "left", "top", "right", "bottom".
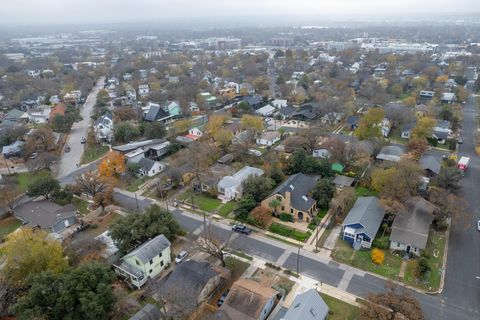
{"left": 57, "top": 78, "right": 105, "bottom": 177}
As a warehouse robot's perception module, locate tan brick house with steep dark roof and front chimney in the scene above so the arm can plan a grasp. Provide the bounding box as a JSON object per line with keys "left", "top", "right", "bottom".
{"left": 261, "top": 173, "right": 318, "bottom": 222}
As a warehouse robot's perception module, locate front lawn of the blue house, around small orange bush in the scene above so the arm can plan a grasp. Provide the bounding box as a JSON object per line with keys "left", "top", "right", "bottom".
{"left": 332, "top": 239, "right": 402, "bottom": 280}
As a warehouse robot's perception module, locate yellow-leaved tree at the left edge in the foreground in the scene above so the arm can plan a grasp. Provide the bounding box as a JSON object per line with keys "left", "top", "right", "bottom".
{"left": 1, "top": 228, "right": 68, "bottom": 287}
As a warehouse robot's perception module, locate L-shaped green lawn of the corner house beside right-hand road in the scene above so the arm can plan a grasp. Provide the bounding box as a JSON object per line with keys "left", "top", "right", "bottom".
{"left": 404, "top": 229, "right": 445, "bottom": 291}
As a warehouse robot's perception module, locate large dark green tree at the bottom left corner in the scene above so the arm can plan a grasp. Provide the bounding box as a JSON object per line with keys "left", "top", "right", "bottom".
{"left": 13, "top": 263, "right": 115, "bottom": 320}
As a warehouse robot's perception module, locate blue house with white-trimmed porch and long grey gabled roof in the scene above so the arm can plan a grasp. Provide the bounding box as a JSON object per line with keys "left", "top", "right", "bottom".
{"left": 342, "top": 197, "right": 385, "bottom": 250}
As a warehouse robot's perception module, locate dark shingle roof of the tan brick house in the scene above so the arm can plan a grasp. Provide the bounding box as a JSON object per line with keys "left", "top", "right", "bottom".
{"left": 270, "top": 173, "right": 318, "bottom": 212}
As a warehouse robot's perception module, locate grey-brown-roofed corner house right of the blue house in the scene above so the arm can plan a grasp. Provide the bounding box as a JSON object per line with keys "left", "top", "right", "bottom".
{"left": 390, "top": 197, "right": 435, "bottom": 256}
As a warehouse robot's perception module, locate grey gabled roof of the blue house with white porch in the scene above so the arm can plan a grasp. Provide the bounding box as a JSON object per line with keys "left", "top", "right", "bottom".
{"left": 342, "top": 197, "right": 385, "bottom": 239}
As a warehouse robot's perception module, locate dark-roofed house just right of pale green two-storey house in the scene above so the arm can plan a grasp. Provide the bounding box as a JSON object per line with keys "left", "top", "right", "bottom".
{"left": 158, "top": 260, "right": 230, "bottom": 314}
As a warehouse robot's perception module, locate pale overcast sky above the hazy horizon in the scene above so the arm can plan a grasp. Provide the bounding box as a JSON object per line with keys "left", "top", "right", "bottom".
{"left": 0, "top": 0, "right": 480, "bottom": 25}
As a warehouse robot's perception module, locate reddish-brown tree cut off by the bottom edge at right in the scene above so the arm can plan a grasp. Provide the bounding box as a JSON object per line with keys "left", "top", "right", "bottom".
{"left": 358, "top": 286, "right": 425, "bottom": 320}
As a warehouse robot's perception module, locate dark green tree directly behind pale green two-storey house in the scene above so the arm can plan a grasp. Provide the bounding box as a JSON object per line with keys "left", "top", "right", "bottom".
{"left": 110, "top": 204, "right": 180, "bottom": 253}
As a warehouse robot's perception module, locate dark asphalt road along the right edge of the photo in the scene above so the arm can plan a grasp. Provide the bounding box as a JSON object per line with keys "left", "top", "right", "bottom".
{"left": 442, "top": 97, "right": 480, "bottom": 319}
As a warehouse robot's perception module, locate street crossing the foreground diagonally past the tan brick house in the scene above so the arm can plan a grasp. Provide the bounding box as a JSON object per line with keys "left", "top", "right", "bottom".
{"left": 110, "top": 191, "right": 479, "bottom": 320}
